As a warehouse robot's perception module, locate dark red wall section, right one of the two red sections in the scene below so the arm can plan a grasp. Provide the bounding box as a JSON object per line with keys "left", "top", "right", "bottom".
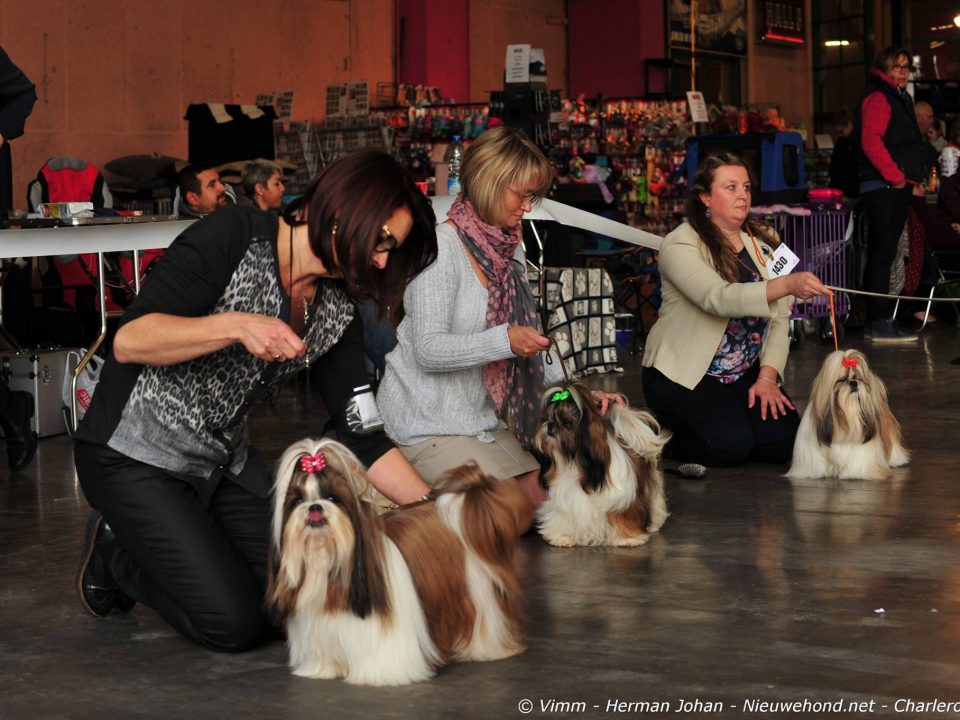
{"left": 567, "top": 0, "right": 666, "bottom": 97}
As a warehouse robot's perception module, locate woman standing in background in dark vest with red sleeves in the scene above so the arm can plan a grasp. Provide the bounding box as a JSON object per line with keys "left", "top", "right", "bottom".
{"left": 859, "top": 47, "right": 928, "bottom": 343}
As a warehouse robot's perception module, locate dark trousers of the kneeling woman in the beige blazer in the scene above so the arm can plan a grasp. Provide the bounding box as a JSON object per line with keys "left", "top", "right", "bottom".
{"left": 643, "top": 366, "right": 800, "bottom": 467}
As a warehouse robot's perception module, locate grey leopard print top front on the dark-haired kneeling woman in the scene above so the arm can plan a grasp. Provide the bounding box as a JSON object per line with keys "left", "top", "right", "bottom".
{"left": 107, "top": 211, "right": 355, "bottom": 486}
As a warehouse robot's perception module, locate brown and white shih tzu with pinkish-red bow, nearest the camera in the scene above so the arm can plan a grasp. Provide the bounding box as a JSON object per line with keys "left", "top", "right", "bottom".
{"left": 267, "top": 440, "right": 530, "bottom": 685}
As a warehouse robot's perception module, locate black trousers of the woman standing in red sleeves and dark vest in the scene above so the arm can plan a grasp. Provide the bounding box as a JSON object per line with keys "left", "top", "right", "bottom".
{"left": 860, "top": 185, "right": 912, "bottom": 323}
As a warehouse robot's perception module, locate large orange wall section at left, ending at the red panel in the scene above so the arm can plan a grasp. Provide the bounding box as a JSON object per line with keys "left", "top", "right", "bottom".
{"left": 0, "top": 0, "right": 394, "bottom": 206}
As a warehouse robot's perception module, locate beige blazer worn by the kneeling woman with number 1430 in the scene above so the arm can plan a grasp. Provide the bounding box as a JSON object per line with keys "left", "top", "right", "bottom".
{"left": 643, "top": 223, "right": 792, "bottom": 390}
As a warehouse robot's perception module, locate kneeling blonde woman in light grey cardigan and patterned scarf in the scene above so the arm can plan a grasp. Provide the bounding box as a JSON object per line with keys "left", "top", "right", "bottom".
{"left": 377, "top": 127, "right": 616, "bottom": 507}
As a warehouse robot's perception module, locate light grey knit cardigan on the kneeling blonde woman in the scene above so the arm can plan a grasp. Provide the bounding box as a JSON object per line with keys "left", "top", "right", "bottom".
{"left": 377, "top": 223, "right": 562, "bottom": 445}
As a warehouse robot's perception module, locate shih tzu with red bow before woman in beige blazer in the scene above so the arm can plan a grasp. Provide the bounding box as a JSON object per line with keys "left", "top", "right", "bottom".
{"left": 787, "top": 350, "right": 910, "bottom": 480}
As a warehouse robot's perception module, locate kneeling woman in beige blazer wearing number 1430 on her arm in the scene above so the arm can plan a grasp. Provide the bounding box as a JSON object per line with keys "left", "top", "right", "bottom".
{"left": 643, "top": 153, "right": 829, "bottom": 466}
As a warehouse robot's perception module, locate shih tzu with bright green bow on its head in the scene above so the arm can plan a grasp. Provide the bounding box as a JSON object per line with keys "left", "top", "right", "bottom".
{"left": 533, "top": 382, "right": 670, "bottom": 546}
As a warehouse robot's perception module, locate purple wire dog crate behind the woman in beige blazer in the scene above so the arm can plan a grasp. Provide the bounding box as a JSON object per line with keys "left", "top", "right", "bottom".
{"left": 754, "top": 208, "right": 850, "bottom": 320}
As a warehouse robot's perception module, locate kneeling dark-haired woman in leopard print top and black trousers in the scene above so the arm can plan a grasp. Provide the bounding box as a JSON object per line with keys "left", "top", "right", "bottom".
{"left": 74, "top": 151, "right": 437, "bottom": 651}
